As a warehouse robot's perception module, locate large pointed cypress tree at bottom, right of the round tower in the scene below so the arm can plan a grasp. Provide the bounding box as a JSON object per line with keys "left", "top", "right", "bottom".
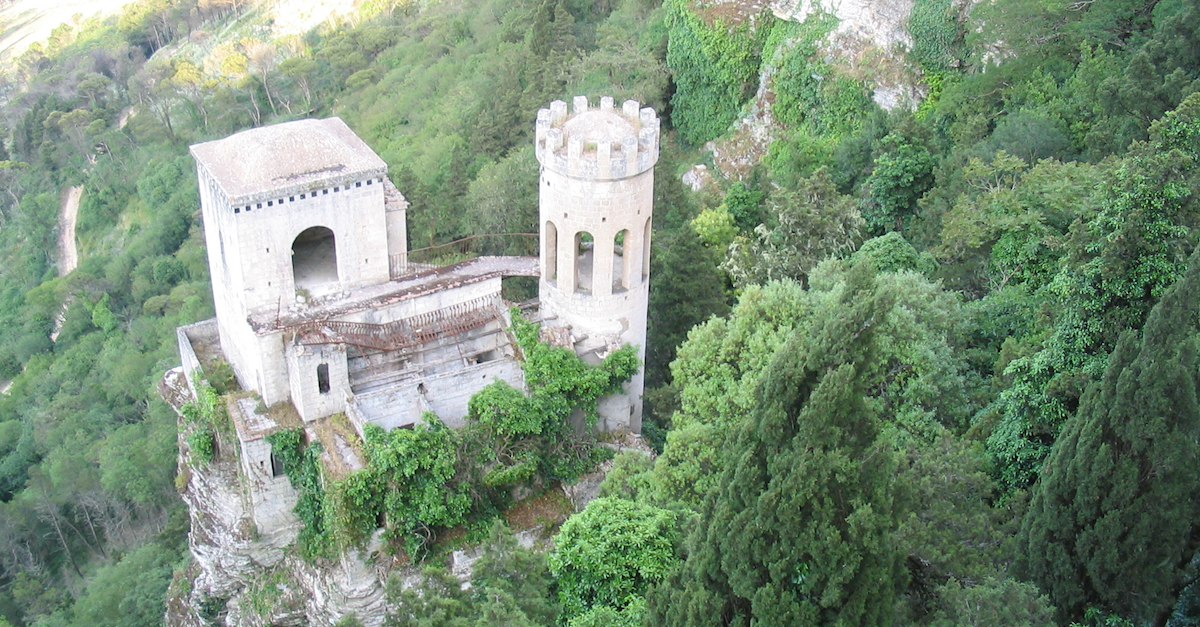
{"left": 648, "top": 264, "right": 900, "bottom": 627}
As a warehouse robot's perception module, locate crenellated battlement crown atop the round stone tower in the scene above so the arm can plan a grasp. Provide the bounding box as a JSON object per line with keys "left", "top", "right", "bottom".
{"left": 535, "top": 96, "right": 659, "bottom": 180}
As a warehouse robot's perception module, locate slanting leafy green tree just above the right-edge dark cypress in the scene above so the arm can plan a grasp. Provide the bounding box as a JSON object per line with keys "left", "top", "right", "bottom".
{"left": 988, "top": 94, "right": 1200, "bottom": 488}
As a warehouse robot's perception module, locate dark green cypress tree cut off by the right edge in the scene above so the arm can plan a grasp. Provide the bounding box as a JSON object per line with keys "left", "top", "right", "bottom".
{"left": 1020, "top": 246, "right": 1200, "bottom": 625}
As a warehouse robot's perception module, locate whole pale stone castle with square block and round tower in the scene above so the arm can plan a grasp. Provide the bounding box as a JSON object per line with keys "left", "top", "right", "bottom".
{"left": 179, "top": 97, "right": 659, "bottom": 535}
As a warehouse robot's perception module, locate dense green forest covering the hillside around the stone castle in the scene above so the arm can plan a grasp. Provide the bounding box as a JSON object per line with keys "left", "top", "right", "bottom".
{"left": 0, "top": 0, "right": 1200, "bottom": 627}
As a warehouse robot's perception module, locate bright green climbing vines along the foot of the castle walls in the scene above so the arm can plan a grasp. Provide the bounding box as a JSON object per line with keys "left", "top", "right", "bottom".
{"left": 266, "top": 311, "right": 640, "bottom": 559}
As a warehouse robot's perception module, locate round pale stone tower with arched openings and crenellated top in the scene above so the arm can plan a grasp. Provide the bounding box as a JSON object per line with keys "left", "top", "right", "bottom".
{"left": 536, "top": 96, "right": 659, "bottom": 431}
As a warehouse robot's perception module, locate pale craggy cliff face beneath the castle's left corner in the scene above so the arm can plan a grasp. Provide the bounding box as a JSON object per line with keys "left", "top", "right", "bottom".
{"left": 160, "top": 369, "right": 395, "bottom": 627}
